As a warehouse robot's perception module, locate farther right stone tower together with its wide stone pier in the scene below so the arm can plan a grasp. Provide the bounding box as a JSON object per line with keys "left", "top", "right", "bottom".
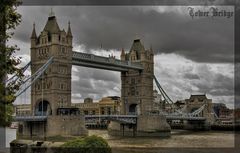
{"left": 108, "top": 39, "right": 171, "bottom": 137}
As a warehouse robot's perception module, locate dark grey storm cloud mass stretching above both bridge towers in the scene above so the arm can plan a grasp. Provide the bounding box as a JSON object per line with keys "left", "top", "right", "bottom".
{"left": 16, "top": 6, "right": 234, "bottom": 62}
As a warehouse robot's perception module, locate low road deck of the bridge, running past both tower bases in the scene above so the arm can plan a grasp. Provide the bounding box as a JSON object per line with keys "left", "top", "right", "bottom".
{"left": 14, "top": 115, "right": 206, "bottom": 124}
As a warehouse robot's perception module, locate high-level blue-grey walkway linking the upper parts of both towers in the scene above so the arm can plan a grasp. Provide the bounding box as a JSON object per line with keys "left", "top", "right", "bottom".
{"left": 72, "top": 51, "right": 143, "bottom": 72}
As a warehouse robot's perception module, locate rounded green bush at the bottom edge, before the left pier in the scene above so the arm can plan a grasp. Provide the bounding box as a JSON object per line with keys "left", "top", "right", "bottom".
{"left": 58, "top": 136, "right": 111, "bottom": 153}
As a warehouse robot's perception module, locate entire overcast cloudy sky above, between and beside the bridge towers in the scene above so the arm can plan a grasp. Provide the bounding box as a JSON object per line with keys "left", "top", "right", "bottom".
{"left": 11, "top": 6, "right": 234, "bottom": 108}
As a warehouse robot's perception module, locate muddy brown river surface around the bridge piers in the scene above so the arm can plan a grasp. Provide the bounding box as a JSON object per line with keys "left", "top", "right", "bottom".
{"left": 2, "top": 128, "right": 237, "bottom": 153}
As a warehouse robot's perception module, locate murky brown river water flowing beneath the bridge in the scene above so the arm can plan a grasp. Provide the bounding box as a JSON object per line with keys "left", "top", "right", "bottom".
{"left": 2, "top": 128, "right": 234, "bottom": 151}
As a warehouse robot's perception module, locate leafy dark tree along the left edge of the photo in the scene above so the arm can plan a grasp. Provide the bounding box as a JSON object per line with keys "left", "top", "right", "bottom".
{"left": 0, "top": 0, "right": 23, "bottom": 126}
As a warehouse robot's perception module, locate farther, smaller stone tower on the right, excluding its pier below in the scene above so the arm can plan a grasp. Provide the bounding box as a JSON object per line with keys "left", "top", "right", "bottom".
{"left": 121, "top": 39, "right": 154, "bottom": 115}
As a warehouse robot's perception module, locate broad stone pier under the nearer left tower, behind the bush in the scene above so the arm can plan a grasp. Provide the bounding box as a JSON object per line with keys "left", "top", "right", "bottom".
{"left": 18, "top": 115, "right": 88, "bottom": 140}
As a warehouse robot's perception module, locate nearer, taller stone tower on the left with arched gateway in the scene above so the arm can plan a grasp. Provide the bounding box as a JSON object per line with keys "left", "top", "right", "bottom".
{"left": 31, "top": 13, "right": 72, "bottom": 115}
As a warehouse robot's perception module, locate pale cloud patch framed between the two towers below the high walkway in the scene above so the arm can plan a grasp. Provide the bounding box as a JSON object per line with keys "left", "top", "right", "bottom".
{"left": 72, "top": 67, "right": 121, "bottom": 101}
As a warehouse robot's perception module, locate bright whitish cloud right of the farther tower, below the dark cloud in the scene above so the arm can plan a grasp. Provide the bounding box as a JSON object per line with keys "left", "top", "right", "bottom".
{"left": 155, "top": 55, "right": 234, "bottom": 107}
